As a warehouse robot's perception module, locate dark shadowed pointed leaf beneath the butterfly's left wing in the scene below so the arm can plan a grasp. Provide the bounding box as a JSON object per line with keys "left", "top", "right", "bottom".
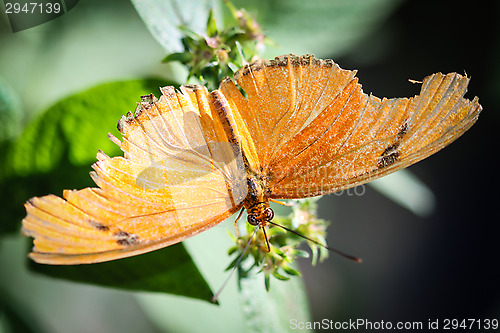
{"left": 30, "top": 244, "right": 213, "bottom": 301}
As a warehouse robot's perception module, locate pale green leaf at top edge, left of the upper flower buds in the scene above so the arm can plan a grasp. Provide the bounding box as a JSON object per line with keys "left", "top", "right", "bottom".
{"left": 131, "top": 0, "right": 220, "bottom": 53}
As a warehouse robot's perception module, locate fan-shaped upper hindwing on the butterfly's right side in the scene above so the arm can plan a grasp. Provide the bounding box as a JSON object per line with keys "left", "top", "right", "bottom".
{"left": 224, "top": 56, "right": 355, "bottom": 170}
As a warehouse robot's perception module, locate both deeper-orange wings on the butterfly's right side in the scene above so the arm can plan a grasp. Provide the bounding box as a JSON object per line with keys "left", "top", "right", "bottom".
{"left": 220, "top": 55, "right": 481, "bottom": 198}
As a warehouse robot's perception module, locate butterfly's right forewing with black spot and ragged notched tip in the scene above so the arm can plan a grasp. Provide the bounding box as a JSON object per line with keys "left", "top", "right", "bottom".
{"left": 270, "top": 74, "right": 481, "bottom": 198}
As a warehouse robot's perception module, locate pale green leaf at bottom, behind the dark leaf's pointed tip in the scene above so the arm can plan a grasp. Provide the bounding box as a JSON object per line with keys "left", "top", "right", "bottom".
{"left": 137, "top": 227, "right": 311, "bottom": 332}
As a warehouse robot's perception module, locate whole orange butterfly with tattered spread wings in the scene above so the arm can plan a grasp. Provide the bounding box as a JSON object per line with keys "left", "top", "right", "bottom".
{"left": 22, "top": 55, "right": 482, "bottom": 264}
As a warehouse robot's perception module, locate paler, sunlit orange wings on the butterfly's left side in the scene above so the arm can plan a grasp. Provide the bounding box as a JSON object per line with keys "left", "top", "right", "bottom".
{"left": 22, "top": 86, "right": 246, "bottom": 264}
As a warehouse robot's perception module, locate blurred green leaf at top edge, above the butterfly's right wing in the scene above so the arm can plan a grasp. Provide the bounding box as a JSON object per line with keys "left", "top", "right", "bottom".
{"left": 233, "top": 0, "right": 402, "bottom": 58}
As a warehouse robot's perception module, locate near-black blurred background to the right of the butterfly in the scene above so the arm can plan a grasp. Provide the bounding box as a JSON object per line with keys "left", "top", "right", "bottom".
{"left": 302, "top": 1, "right": 500, "bottom": 323}
